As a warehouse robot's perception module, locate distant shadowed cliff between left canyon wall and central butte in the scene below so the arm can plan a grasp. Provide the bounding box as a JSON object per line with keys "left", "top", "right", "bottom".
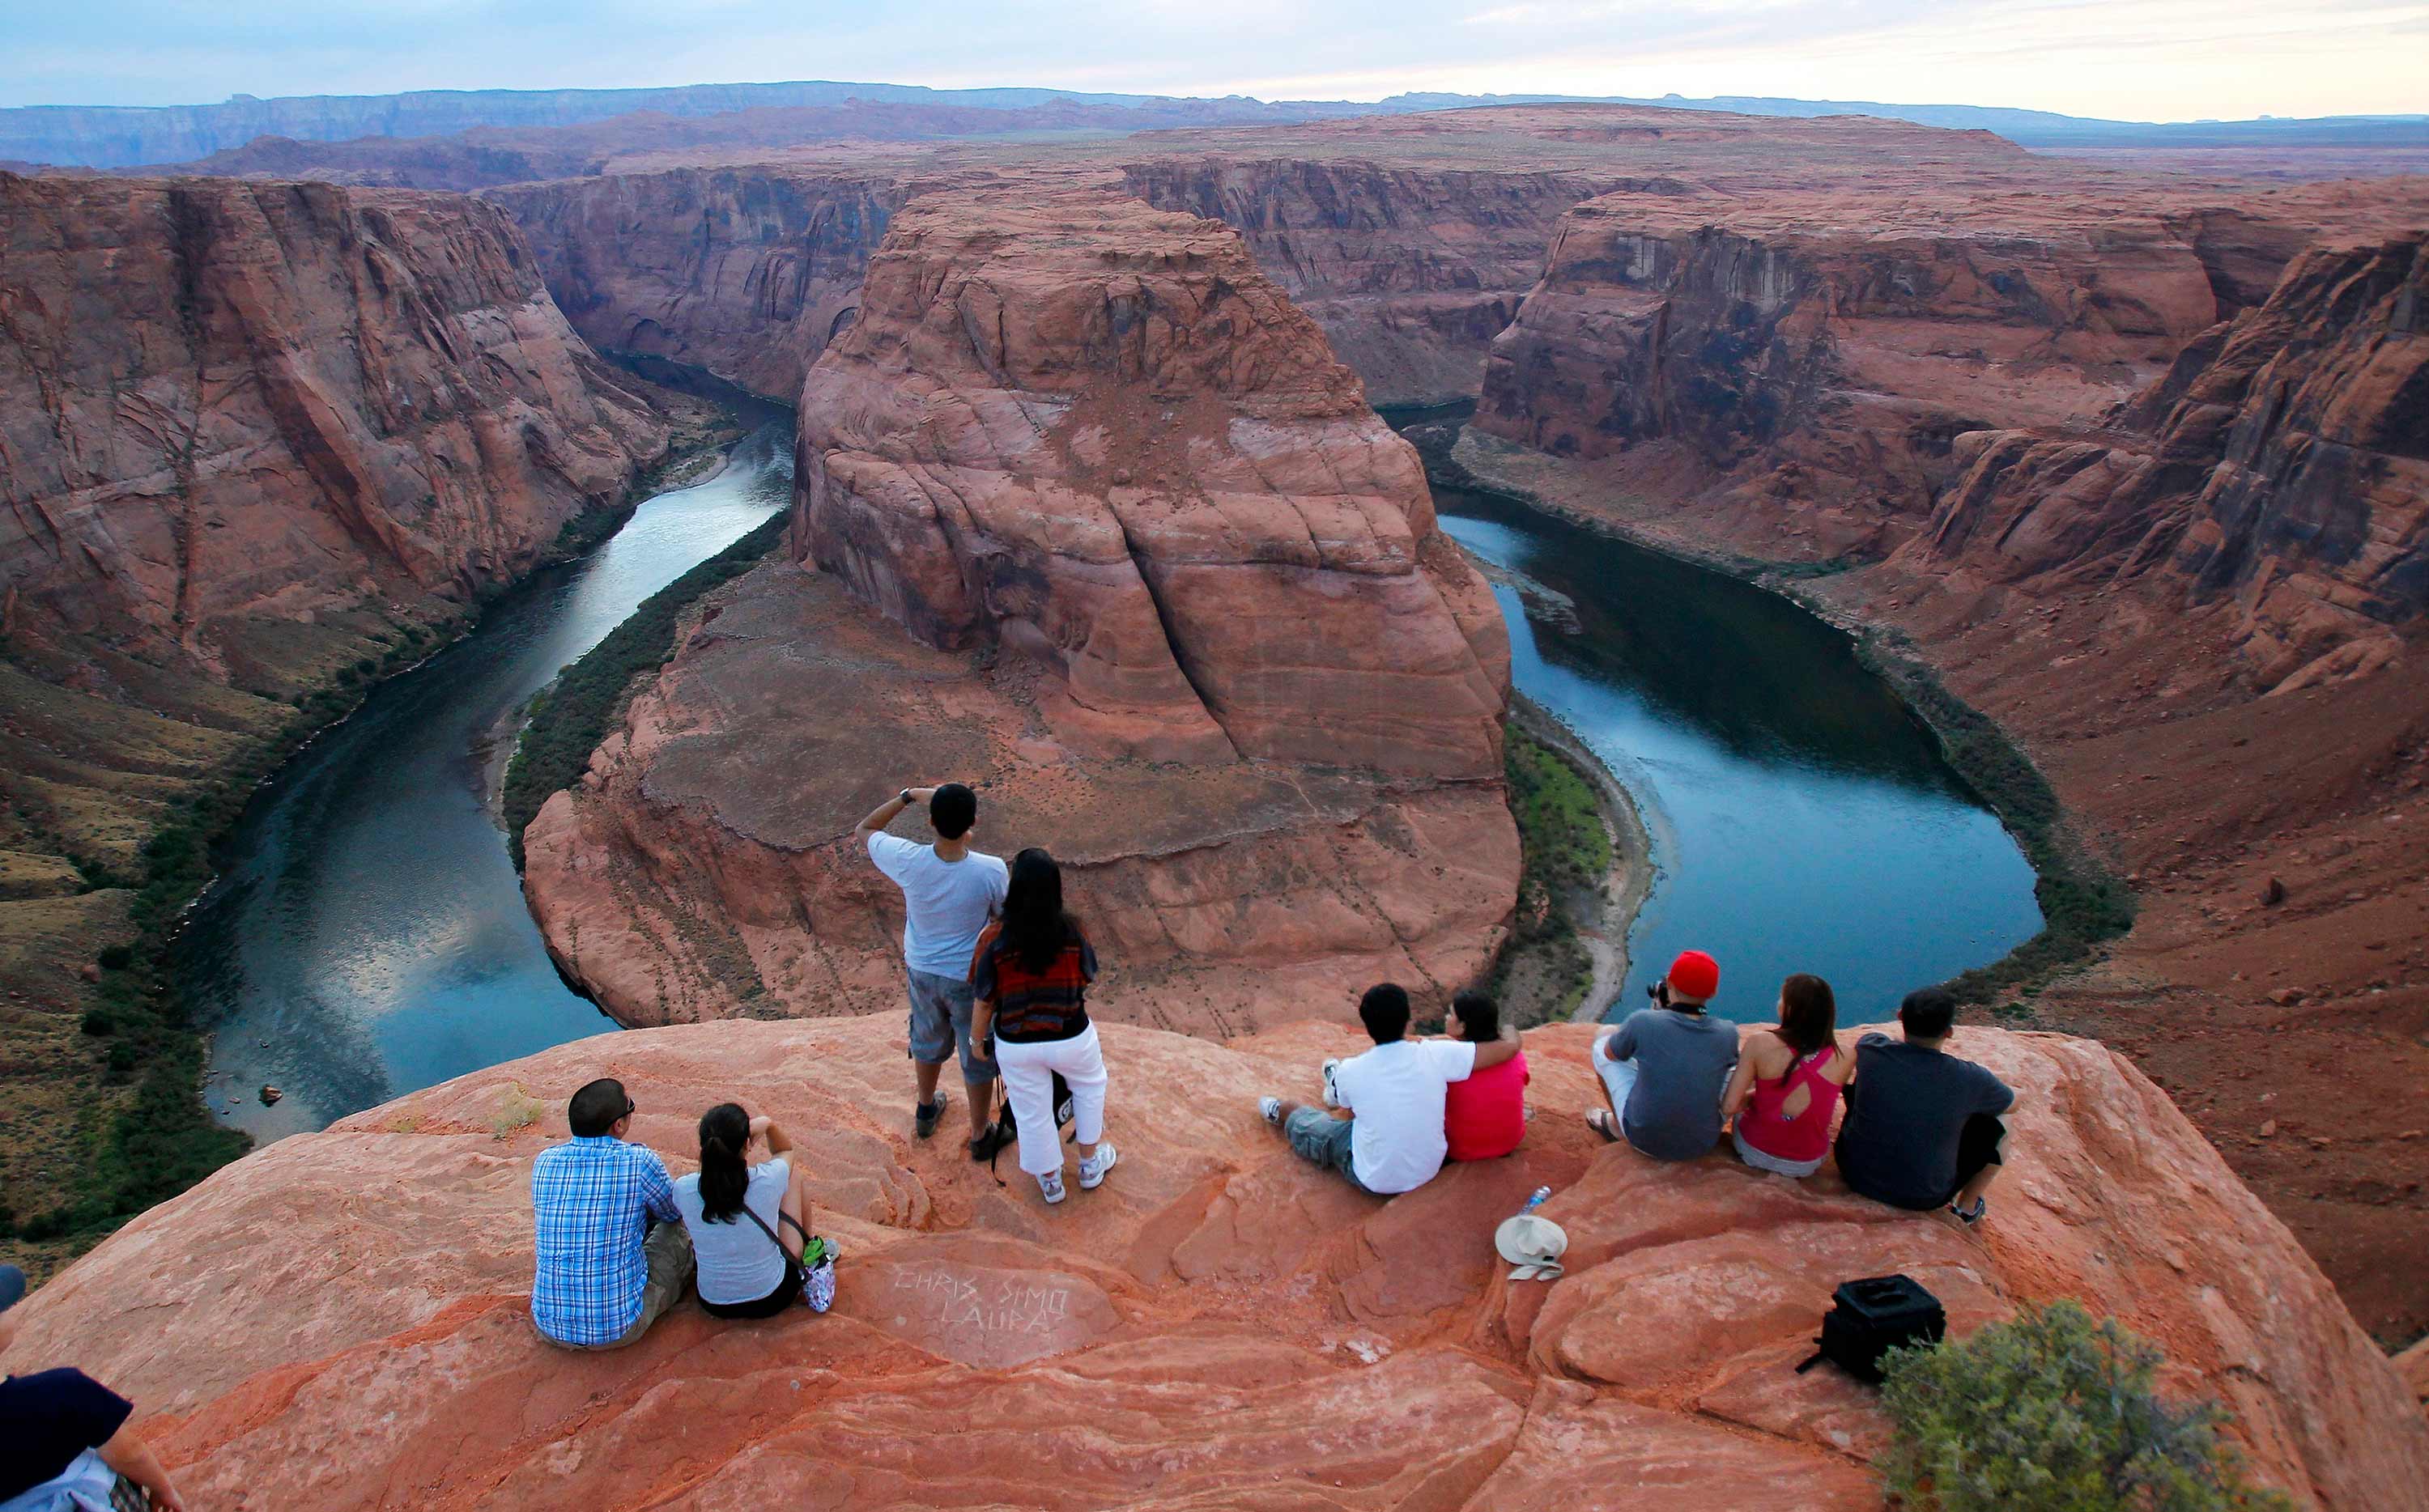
{"left": 488, "top": 168, "right": 908, "bottom": 403}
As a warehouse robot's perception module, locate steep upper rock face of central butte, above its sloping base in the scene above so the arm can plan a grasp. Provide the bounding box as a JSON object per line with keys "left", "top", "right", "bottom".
{"left": 792, "top": 192, "right": 1508, "bottom": 779}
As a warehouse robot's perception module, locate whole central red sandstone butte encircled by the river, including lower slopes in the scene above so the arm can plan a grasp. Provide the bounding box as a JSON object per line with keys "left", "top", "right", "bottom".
{"left": 525, "top": 192, "right": 1518, "bottom": 1034}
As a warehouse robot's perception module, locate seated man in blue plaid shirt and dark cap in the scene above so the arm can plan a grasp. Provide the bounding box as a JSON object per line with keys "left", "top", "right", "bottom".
{"left": 532, "top": 1077, "right": 692, "bottom": 1349}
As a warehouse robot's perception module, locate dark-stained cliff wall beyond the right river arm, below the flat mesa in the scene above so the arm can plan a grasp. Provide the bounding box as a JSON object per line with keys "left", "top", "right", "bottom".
{"left": 1477, "top": 187, "right": 2223, "bottom": 554}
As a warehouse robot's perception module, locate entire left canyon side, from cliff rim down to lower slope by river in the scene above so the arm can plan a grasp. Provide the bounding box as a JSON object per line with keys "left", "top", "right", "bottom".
{"left": 0, "top": 175, "right": 668, "bottom": 1252}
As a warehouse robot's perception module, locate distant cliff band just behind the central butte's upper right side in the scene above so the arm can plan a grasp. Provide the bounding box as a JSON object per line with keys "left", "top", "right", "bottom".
{"left": 1122, "top": 155, "right": 1613, "bottom": 403}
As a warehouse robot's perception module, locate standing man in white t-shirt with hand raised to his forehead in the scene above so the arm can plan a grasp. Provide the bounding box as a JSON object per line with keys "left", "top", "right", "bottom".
{"left": 853, "top": 781, "right": 1010, "bottom": 1160}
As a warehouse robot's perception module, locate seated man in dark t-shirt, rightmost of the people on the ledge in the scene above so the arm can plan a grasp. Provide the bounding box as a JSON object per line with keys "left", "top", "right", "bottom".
{"left": 1839, "top": 987, "right": 2016, "bottom": 1223}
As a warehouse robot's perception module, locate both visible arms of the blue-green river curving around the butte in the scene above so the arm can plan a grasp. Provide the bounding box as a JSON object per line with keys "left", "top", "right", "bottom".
{"left": 180, "top": 407, "right": 2040, "bottom": 1140}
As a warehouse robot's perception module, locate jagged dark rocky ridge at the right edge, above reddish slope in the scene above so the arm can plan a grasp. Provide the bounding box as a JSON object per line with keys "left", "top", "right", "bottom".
{"left": 1912, "top": 236, "right": 2429, "bottom": 690}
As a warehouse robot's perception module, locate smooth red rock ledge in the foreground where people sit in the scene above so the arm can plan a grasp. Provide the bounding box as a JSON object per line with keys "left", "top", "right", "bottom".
{"left": 10, "top": 1019, "right": 2429, "bottom": 1510}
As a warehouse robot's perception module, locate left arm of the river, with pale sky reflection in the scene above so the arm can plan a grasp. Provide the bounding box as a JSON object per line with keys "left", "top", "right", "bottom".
{"left": 180, "top": 419, "right": 792, "bottom": 1140}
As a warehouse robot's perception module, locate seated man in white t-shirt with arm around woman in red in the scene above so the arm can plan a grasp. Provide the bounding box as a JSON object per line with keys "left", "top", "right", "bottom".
{"left": 1258, "top": 983, "right": 1518, "bottom": 1196}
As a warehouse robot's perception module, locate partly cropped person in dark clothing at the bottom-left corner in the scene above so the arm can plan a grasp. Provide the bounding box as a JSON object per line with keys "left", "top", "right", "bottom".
{"left": 0, "top": 1264, "right": 185, "bottom": 1512}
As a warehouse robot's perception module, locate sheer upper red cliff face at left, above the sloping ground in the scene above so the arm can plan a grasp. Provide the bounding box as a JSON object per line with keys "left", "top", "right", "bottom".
{"left": 0, "top": 175, "right": 666, "bottom": 677}
